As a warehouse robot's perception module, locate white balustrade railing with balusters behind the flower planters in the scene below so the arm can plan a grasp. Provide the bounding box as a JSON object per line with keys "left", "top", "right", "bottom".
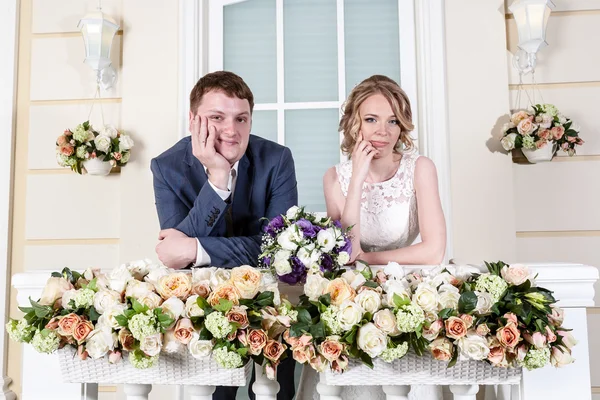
{"left": 12, "top": 263, "right": 598, "bottom": 400}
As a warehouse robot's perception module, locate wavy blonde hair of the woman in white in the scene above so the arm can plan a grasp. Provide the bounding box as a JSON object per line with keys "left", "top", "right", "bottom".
{"left": 338, "top": 75, "right": 415, "bottom": 154}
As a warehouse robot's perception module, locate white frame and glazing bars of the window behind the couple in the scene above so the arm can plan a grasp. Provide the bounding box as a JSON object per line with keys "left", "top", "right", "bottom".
{"left": 179, "top": 0, "right": 453, "bottom": 260}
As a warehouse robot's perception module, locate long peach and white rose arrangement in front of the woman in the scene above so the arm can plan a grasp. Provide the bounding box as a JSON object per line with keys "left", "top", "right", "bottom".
{"left": 284, "top": 262, "right": 576, "bottom": 372}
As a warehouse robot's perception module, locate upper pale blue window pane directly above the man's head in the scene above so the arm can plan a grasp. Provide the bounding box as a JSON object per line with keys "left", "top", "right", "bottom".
{"left": 223, "top": 0, "right": 277, "bottom": 103}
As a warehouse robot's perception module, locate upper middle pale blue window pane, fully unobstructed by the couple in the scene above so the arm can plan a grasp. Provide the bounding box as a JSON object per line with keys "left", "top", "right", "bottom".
{"left": 283, "top": 0, "right": 338, "bottom": 102}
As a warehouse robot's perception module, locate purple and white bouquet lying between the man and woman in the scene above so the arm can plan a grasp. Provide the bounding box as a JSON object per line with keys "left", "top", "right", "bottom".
{"left": 259, "top": 206, "right": 352, "bottom": 285}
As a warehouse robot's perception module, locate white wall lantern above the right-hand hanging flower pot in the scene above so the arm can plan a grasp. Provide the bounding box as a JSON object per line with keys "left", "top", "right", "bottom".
{"left": 508, "top": 0, "right": 555, "bottom": 74}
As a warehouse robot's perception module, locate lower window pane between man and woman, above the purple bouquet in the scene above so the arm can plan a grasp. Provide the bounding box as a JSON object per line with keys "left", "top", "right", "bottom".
{"left": 285, "top": 109, "right": 340, "bottom": 211}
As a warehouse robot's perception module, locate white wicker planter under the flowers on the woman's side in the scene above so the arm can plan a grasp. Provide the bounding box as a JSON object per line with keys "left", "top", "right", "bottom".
{"left": 321, "top": 352, "right": 522, "bottom": 386}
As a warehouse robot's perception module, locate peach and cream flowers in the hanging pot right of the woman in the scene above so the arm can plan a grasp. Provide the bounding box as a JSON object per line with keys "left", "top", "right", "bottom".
{"left": 501, "top": 104, "right": 583, "bottom": 156}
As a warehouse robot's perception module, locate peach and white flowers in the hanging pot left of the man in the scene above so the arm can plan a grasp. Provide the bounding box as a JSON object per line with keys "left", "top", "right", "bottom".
{"left": 56, "top": 121, "right": 133, "bottom": 174}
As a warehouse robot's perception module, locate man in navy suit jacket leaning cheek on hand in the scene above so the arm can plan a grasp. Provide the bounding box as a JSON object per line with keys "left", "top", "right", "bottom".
{"left": 151, "top": 71, "right": 298, "bottom": 400}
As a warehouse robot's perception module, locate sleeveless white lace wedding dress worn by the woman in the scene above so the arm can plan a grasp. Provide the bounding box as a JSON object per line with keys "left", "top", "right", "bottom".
{"left": 296, "top": 153, "right": 442, "bottom": 400}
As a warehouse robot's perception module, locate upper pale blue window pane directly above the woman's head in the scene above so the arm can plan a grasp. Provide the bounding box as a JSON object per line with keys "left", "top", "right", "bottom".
{"left": 344, "top": 0, "right": 400, "bottom": 96}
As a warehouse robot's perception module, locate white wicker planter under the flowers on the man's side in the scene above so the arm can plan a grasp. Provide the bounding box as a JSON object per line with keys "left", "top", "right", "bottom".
{"left": 57, "top": 346, "right": 252, "bottom": 386}
